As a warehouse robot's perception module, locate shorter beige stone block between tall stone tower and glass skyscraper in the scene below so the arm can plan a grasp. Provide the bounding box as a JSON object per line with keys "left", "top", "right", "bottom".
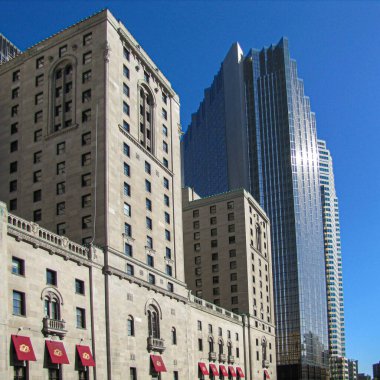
{"left": 182, "top": 188, "right": 276, "bottom": 379}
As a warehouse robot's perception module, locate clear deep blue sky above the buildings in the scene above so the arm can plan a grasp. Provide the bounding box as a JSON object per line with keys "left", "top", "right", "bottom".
{"left": 0, "top": 0, "right": 380, "bottom": 375}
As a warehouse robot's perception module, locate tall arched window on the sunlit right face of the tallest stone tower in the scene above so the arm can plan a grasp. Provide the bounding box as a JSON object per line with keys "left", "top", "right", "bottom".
{"left": 139, "top": 86, "right": 154, "bottom": 153}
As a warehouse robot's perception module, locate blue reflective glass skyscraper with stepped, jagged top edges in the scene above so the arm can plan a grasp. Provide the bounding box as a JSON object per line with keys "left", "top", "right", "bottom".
{"left": 182, "top": 39, "right": 328, "bottom": 380}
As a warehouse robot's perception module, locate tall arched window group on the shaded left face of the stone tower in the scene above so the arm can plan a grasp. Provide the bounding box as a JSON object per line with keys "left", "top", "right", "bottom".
{"left": 50, "top": 59, "right": 76, "bottom": 132}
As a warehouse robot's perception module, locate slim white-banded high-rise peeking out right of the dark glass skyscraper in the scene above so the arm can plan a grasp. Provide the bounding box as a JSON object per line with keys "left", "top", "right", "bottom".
{"left": 318, "top": 140, "right": 348, "bottom": 380}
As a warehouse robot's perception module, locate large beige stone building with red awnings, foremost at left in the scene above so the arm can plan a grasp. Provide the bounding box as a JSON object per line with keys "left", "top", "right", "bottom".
{"left": 0, "top": 6, "right": 276, "bottom": 380}
